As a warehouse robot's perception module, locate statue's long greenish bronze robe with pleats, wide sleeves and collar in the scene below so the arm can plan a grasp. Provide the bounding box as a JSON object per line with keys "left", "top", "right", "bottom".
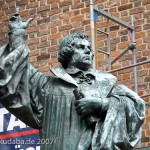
{"left": 0, "top": 44, "right": 145, "bottom": 150}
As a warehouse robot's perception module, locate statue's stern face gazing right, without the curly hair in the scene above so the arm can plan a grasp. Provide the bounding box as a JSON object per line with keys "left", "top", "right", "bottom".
{"left": 70, "top": 39, "right": 93, "bottom": 70}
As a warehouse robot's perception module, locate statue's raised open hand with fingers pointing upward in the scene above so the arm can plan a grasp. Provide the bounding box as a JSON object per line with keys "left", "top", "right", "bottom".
{"left": 9, "top": 8, "right": 33, "bottom": 31}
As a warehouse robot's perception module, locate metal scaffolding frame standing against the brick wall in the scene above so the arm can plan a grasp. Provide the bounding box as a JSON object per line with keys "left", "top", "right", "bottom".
{"left": 90, "top": 0, "right": 150, "bottom": 97}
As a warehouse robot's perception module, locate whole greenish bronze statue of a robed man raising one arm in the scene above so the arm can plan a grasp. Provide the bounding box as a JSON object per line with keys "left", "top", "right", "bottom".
{"left": 0, "top": 10, "right": 145, "bottom": 150}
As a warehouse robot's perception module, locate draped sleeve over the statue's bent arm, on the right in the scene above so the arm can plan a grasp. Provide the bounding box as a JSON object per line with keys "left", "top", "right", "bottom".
{"left": 108, "top": 85, "right": 145, "bottom": 147}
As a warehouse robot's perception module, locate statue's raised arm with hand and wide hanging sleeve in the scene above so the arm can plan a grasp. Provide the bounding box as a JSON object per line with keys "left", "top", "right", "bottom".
{"left": 0, "top": 9, "right": 46, "bottom": 128}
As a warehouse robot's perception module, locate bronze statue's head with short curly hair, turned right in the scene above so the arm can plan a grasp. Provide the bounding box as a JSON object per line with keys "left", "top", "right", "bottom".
{"left": 58, "top": 32, "right": 94, "bottom": 69}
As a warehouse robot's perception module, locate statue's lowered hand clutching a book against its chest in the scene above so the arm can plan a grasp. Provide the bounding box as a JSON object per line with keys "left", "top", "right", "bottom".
{"left": 75, "top": 97, "right": 102, "bottom": 117}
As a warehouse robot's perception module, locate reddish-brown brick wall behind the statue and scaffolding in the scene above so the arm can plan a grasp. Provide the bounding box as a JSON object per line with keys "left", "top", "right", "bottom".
{"left": 0, "top": 0, "right": 150, "bottom": 146}
